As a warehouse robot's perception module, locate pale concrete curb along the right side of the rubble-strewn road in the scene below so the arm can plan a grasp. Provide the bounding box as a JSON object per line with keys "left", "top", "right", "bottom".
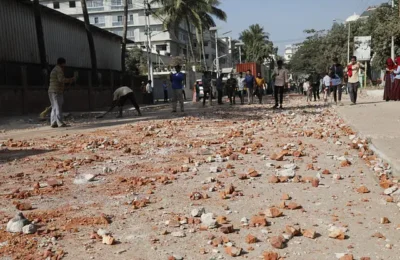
{"left": 335, "top": 109, "right": 400, "bottom": 179}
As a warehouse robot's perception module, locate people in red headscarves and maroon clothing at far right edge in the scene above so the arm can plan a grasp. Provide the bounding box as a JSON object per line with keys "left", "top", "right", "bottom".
{"left": 383, "top": 57, "right": 400, "bottom": 101}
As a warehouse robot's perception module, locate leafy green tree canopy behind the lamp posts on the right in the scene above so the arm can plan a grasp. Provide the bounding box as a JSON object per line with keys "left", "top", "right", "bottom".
{"left": 291, "top": 4, "right": 400, "bottom": 73}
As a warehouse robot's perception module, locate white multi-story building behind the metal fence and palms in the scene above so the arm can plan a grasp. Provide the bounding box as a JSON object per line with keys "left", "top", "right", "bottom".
{"left": 40, "top": 0, "right": 227, "bottom": 71}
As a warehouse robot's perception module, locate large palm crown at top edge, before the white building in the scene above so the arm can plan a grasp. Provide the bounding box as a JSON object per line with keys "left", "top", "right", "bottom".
{"left": 152, "top": 0, "right": 227, "bottom": 62}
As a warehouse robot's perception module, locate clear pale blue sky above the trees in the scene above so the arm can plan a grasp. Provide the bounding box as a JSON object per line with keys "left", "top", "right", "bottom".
{"left": 217, "top": 0, "right": 388, "bottom": 55}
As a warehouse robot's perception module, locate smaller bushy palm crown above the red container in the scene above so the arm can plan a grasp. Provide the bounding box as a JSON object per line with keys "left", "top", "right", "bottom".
{"left": 239, "top": 24, "right": 274, "bottom": 62}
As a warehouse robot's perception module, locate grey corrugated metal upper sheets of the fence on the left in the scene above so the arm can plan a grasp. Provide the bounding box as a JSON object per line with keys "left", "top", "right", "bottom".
{"left": 0, "top": 0, "right": 121, "bottom": 71}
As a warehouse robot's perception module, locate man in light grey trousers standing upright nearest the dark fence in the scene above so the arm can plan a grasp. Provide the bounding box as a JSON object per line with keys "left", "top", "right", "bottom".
{"left": 48, "top": 58, "right": 75, "bottom": 128}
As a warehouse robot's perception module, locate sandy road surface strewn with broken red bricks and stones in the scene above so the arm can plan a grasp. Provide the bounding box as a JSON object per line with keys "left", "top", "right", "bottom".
{"left": 0, "top": 97, "right": 400, "bottom": 260}
